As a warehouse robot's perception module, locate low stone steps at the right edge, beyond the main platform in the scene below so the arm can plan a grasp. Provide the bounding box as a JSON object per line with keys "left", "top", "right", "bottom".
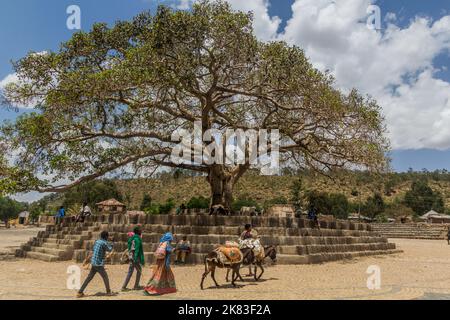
{"left": 371, "top": 223, "right": 448, "bottom": 240}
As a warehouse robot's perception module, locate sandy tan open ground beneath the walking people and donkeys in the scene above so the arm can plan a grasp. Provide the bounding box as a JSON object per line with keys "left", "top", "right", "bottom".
{"left": 0, "top": 230, "right": 450, "bottom": 300}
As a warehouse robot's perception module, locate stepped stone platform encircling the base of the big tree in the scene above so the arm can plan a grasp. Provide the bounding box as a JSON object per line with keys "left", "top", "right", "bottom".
{"left": 16, "top": 215, "right": 400, "bottom": 264}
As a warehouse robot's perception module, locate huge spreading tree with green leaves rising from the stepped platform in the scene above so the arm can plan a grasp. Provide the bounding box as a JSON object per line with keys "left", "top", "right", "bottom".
{"left": 0, "top": 0, "right": 388, "bottom": 206}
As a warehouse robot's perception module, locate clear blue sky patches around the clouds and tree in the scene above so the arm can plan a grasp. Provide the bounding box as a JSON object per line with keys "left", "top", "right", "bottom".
{"left": 0, "top": 0, "right": 450, "bottom": 171}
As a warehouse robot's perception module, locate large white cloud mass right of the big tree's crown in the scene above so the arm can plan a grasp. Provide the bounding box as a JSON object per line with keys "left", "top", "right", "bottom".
{"left": 279, "top": 0, "right": 450, "bottom": 149}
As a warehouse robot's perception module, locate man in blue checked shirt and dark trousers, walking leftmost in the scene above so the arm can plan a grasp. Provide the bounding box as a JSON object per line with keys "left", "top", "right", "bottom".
{"left": 77, "top": 231, "right": 113, "bottom": 298}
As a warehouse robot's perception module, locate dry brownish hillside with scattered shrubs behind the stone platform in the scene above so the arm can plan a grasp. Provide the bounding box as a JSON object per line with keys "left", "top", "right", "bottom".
{"left": 35, "top": 172, "right": 450, "bottom": 215}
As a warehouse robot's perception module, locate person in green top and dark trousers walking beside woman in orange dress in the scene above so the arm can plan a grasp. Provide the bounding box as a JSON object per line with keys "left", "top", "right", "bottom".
{"left": 122, "top": 227, "right": 145, "bottom": 291}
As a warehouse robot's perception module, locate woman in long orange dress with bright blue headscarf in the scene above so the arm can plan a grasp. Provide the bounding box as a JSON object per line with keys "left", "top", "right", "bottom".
{"left": 144, "top": 232, "right": 177, "bottom": 296}
